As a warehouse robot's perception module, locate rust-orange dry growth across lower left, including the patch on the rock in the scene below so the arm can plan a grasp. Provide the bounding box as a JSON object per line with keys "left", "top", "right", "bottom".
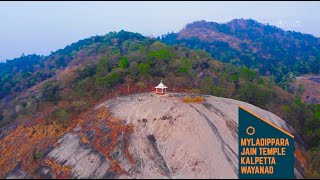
{"left": 0, "top": 102, "right": 135, "bottom": 178}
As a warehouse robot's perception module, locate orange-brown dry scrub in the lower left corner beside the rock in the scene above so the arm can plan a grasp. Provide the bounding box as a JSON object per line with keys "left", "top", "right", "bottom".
{"left": 0, "top": 123, "right": 71, "bottom": 178}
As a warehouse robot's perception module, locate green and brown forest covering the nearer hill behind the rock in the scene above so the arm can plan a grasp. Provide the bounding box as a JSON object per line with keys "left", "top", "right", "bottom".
{"left": 0, "top": 25, "right": 320, "bottom": 176}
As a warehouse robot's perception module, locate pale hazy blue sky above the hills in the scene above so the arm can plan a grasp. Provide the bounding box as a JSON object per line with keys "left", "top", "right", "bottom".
{"left": 0, "top": 1, "right": 320, "bottom": 61}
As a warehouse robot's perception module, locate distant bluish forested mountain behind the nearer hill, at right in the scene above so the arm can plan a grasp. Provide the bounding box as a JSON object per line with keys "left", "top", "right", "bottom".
{"left": 161, "top": 19, "right": 320, "bottom": 87}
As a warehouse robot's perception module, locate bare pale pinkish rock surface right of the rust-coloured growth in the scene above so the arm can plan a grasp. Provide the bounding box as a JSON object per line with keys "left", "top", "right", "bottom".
{"left": 97, "top": 94, "right": 301, "bottom": 178}
